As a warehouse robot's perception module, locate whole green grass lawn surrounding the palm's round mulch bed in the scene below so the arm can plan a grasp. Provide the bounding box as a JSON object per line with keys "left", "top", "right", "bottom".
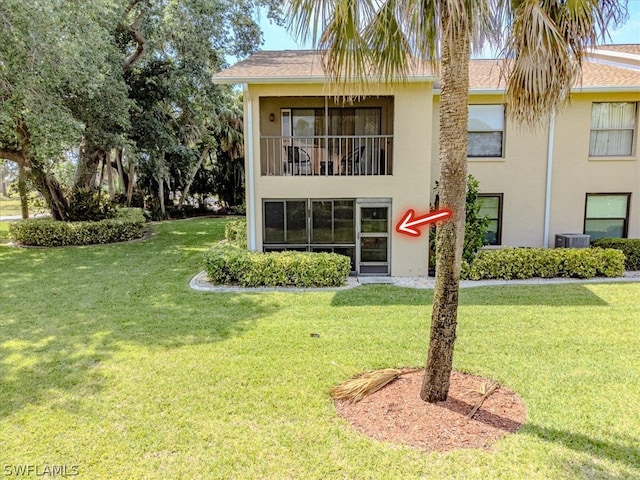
{"left": 0, "top": 219, "right": 640, "bottom": 480}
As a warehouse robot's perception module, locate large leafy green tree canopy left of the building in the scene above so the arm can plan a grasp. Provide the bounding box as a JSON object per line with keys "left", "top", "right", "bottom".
{"left": 0, "top": 0, "right": 279, "bottom": 220}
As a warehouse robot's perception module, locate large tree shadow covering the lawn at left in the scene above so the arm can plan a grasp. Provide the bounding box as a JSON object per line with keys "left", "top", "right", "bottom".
{"left": 0, "top": 219, "right": 280, "bottom": 418}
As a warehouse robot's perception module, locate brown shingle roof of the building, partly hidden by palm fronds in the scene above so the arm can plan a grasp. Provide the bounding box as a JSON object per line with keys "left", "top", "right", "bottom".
{"left": 213, "top": 45, "right": 640, "bottom": 93}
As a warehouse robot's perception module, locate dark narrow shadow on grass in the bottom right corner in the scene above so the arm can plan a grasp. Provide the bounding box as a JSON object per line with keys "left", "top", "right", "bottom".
{"left": 520, "top": 423, "right": 640, "bottom": 472}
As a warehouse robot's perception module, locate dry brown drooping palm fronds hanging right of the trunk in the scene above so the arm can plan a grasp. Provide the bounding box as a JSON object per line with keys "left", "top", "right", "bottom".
{"left": 503, "top": 0, "right": 626, "bottom": 124}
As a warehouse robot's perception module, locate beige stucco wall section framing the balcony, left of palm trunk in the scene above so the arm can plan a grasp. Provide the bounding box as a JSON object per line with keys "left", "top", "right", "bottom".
{"left": 244, "top": 83, "right": 433, "bottom": 276}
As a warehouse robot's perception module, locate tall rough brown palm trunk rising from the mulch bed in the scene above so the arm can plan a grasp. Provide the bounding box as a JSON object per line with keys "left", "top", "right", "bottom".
{"left": 420, "top": 14, "right": 469, "bottom": 403}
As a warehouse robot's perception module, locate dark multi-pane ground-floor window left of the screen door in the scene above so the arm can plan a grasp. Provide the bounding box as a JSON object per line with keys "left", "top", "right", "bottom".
{"left": 263, "top": 199, "right": 355, "bottom": 270}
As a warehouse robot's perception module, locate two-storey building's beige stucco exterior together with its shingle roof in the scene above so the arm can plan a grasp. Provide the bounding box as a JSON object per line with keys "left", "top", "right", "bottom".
{"left": 215, "top": 45, "right": 640, "bottom": 276}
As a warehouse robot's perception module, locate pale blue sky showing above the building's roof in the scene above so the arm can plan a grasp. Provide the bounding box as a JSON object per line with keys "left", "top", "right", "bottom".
{"left": 260, "top": 0, "right": 640, "bottom": 50}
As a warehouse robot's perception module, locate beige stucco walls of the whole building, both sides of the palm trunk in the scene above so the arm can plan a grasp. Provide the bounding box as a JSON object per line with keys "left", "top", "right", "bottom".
{"left": 245, "top": 83, "right": 640, "bottom": 276}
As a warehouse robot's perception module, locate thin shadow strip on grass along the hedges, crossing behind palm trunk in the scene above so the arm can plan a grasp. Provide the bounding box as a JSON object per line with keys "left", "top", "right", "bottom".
{"left": 332, "top": 284, "right": 608, "bottom": 307}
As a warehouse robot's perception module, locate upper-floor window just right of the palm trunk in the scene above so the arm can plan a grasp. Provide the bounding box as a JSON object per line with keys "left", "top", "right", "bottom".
{"left": 467, "top": 105, "right": 504, "bottom": 157}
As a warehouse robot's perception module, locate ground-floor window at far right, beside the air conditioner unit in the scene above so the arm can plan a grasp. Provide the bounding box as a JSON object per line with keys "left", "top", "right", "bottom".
{"left": 584, "top": 193, "right": 631, "bottom": 240}
